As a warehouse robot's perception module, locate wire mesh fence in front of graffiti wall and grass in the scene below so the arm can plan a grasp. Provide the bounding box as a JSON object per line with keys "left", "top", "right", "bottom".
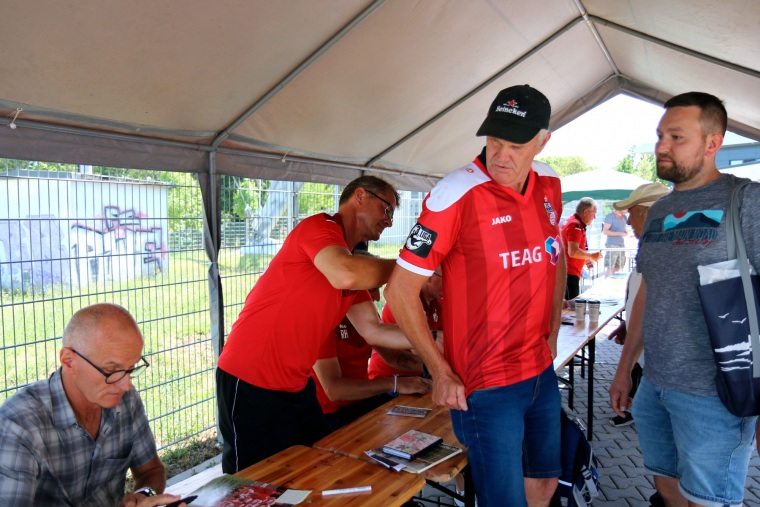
{"left": 0, "top": 159, "right": 423, "bottom": 449}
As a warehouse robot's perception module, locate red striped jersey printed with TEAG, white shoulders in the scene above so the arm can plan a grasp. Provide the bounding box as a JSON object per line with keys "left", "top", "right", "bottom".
{"left": 398, "top": 159, "right": 563, "bottom": 394}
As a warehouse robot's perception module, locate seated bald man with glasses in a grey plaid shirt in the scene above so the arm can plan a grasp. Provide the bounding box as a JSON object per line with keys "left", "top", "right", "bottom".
{"left": 0, "top": 304, "right": 184, "bottom": 507}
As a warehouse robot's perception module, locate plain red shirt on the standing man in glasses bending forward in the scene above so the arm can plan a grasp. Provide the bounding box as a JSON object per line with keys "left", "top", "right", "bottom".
{"left": 218, "top": 213, "right": 371, "bottom": 392}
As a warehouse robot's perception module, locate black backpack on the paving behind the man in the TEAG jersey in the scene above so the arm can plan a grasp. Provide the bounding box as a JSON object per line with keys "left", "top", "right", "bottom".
{"left": 551, "top": 410, "right": 599, "bottom": 507}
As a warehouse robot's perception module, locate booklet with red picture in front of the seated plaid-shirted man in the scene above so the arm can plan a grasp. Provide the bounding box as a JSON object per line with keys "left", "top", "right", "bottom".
{"left": 191, "top": 474, "right": 311, "bottom": 507}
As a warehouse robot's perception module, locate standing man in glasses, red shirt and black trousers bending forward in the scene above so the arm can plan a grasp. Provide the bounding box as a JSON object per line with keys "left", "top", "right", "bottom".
{"left": 216, "top": 176, "right": 411, "bottom": 473}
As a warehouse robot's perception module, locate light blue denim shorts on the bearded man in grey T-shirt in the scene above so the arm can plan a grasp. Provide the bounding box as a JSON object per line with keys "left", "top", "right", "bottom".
{"left": 632, "top": 373, "right": 757, "bottom": 507}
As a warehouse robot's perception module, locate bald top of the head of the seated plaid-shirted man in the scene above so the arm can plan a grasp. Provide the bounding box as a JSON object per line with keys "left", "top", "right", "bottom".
{"left": 63, "top": 303, "right": 142, "bottom": 354}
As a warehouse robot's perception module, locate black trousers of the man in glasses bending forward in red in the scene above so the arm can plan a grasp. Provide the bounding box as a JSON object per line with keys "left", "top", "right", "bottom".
{"left": 216, "top": 368, "right": 330, "bottom": 474}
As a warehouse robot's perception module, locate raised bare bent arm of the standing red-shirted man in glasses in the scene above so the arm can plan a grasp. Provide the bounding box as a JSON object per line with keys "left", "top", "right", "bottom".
{"left": 314, "top": 245, "right": 396, "bottom": 290}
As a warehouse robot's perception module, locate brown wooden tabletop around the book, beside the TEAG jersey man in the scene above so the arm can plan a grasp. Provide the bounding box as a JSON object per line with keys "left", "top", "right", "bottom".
{"left": 314, "top": 393, "right": 467, "bottom": 482}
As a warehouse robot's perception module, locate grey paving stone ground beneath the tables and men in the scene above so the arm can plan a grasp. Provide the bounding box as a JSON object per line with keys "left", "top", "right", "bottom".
{"left": 422, "top": 324, "right": 760, "bottom": 507}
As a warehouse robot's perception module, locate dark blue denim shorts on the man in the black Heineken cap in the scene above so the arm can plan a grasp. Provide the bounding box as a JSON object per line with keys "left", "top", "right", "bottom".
{"left": 451, "top": 366, "right": 562, "bottom": 507}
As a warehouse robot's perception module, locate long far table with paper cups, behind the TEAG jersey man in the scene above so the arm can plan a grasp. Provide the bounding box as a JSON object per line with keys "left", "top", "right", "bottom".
{"left": 554, "top": 278, "right": 626, "bottom": 440}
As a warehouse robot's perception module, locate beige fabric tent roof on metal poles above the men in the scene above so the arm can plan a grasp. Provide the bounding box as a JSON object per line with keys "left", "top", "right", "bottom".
{"left": 0, "top": 0, "right": 760, "bottom": 190}
